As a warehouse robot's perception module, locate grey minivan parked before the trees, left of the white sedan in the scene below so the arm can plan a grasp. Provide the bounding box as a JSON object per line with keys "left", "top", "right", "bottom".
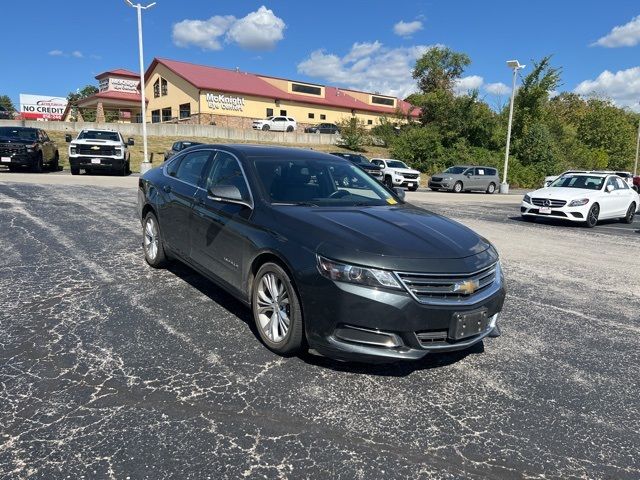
{"left": 429, "top": 165, "right": 500, "bottom": 193}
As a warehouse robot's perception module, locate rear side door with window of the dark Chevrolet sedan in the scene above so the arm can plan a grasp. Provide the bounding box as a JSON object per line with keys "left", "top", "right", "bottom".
{"left": 158, "top": 150, "right": 213, "bottom": 258}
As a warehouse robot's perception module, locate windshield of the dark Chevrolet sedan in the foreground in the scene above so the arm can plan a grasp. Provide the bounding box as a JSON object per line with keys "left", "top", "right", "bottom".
{"left": 254, "top": 157, "right": 398, "bottom": 207}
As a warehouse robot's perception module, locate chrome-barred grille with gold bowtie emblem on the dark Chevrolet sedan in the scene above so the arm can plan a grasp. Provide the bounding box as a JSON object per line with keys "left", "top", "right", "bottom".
{"left": 396, "top": 263, "right": 499, "bottom": 305}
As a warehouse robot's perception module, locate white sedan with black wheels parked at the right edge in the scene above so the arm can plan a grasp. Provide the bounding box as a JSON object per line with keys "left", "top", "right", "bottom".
{"left": 520, "top": 173, "right": 640, "bottom": 227}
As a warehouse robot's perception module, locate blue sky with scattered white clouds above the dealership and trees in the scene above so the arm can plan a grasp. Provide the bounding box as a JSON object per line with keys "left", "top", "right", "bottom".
{"left": 0, "top": 0, "right": 640, "bottom": 109}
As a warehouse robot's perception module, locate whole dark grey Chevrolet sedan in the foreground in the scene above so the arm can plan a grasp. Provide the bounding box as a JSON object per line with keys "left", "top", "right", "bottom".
{"left": 137, "top": 145, "right": 505, "bottom": 362}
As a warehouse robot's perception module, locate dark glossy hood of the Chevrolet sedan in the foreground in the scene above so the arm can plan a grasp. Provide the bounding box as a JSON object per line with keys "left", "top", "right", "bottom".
{"left": 278, "top": 204, "right": 497, "bottom": 273}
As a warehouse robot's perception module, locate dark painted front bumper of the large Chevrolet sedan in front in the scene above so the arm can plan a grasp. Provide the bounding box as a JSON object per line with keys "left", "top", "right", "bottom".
{"left": 301, "top": 277, "right": 505, "bottom": 363}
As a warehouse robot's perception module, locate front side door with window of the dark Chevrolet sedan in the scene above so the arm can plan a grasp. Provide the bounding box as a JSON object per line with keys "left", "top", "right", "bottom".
{"left": 191, "top": 150, "right": 253, "bottom": 290}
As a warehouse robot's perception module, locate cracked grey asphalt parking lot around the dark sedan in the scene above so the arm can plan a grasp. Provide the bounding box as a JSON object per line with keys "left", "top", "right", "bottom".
{"left": 0, "top": 174, "right": 640, "bottom": 479}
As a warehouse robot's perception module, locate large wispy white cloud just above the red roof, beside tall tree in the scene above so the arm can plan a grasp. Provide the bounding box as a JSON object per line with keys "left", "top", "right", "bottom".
{"left": 298, "top": 42, "right": 434, "bottom": 98}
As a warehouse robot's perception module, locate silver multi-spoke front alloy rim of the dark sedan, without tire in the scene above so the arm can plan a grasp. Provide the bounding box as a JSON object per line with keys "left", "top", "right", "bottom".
{"left": 257, "top": 272, "right": 291, "bottom": 343}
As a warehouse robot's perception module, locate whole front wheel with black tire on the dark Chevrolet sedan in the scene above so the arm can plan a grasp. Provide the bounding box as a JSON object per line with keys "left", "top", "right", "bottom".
{"left": 251, "top": 263, "right": 304, "bottom": 355}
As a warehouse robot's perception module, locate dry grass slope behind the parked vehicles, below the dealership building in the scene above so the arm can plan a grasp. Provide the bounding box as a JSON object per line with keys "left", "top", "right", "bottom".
{"left": 47, "top": 131, "right": 389, "bottom": 172}
